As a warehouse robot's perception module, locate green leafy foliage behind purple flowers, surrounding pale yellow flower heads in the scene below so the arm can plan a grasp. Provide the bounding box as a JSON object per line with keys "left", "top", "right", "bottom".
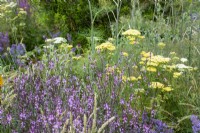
{"left": 0, "top": 0, "right": 200, "bottom": 132}
